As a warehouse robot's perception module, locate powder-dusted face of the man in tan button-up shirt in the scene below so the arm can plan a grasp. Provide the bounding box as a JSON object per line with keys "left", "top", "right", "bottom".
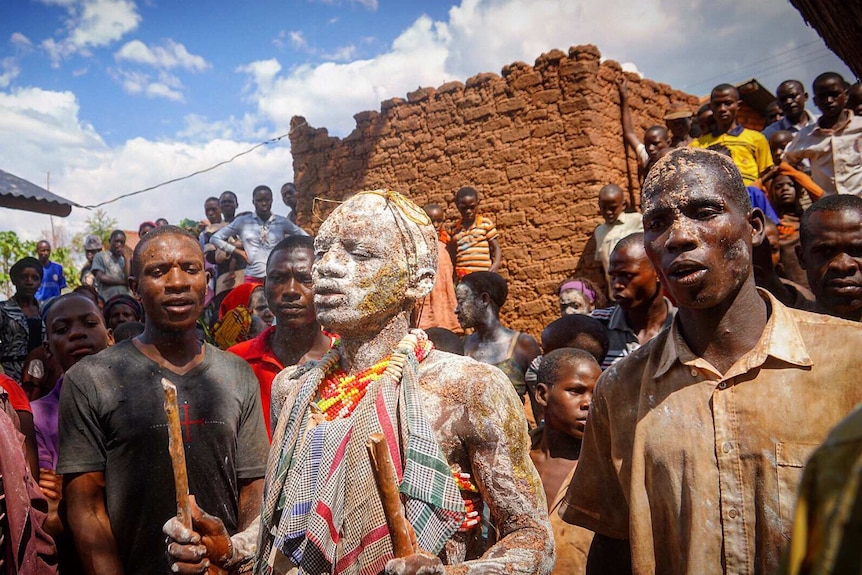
{"left": 643, "top": 165, "right": 763, "bottom": 309}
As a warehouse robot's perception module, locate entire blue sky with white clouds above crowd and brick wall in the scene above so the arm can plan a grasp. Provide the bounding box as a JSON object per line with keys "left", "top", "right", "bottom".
{"left": 0, "top": 0, "right": 851, "bottom": 243}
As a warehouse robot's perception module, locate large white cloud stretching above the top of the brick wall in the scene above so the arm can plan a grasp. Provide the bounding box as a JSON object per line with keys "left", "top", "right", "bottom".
{"left": 233, "top": 0, "right": 846, "bottom": 136}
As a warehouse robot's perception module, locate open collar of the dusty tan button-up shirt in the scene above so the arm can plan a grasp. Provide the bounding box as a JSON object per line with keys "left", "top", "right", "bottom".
{"left": 653, "top": 288, "right": 814, "bottom": 379}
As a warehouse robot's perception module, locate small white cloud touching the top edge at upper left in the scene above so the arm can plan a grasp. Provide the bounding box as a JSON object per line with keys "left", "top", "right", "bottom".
{"left": 40, "top": 0, "right": 141, "bottom": 67}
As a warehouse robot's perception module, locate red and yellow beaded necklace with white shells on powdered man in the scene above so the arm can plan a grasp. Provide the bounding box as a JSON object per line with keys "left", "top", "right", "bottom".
{"left": 317, "top": 330, "right": 434, "bottom": 421}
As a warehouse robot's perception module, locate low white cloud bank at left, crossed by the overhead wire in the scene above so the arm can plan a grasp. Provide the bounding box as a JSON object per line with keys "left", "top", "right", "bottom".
{"left": 0, "top": 86, "right": 293, "bottom": 239}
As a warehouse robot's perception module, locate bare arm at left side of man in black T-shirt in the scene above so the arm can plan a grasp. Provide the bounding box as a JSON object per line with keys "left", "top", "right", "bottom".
{"left": 63, "top": 471, "right": 123, "bottom": 575}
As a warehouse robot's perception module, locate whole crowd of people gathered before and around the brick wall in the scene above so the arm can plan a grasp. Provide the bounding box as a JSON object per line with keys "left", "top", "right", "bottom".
{"left": 0, "top": 73, "right": 862, "bottom": 575}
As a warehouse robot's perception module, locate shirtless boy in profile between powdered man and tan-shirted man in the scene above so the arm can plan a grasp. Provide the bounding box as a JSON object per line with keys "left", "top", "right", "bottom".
{"left": 530, "top": 347, "right": 601, "bottom": 574}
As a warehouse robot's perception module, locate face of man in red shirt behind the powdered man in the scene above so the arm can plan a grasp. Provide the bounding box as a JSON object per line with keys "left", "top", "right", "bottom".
{"left": 266, "top": 248, "right": 315, "bottom": 329}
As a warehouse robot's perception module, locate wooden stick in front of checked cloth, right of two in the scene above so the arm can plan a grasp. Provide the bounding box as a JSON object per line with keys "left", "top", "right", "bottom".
{"left": 365, "top": 433, "right": 416, "bottom": 557}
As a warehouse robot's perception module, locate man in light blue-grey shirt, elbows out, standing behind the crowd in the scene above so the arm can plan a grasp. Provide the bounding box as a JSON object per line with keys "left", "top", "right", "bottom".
{"left": 210, "top": 186, "right": 308, "bottom": 284}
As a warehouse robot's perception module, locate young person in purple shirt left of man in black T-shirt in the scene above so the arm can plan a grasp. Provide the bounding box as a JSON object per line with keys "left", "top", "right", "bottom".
{"left": 30, "top": 293, "right": 113, "bottom": 547}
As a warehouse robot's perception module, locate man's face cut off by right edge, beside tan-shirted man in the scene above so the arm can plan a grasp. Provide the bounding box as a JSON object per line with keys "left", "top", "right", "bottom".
{"left": 797, "top": 210, "right": 862, "bottom": 319}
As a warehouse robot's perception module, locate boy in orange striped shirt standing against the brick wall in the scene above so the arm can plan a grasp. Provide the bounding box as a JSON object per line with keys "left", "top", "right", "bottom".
{"left": 452, "top": 187, "right": 500, "bottom": 279}
